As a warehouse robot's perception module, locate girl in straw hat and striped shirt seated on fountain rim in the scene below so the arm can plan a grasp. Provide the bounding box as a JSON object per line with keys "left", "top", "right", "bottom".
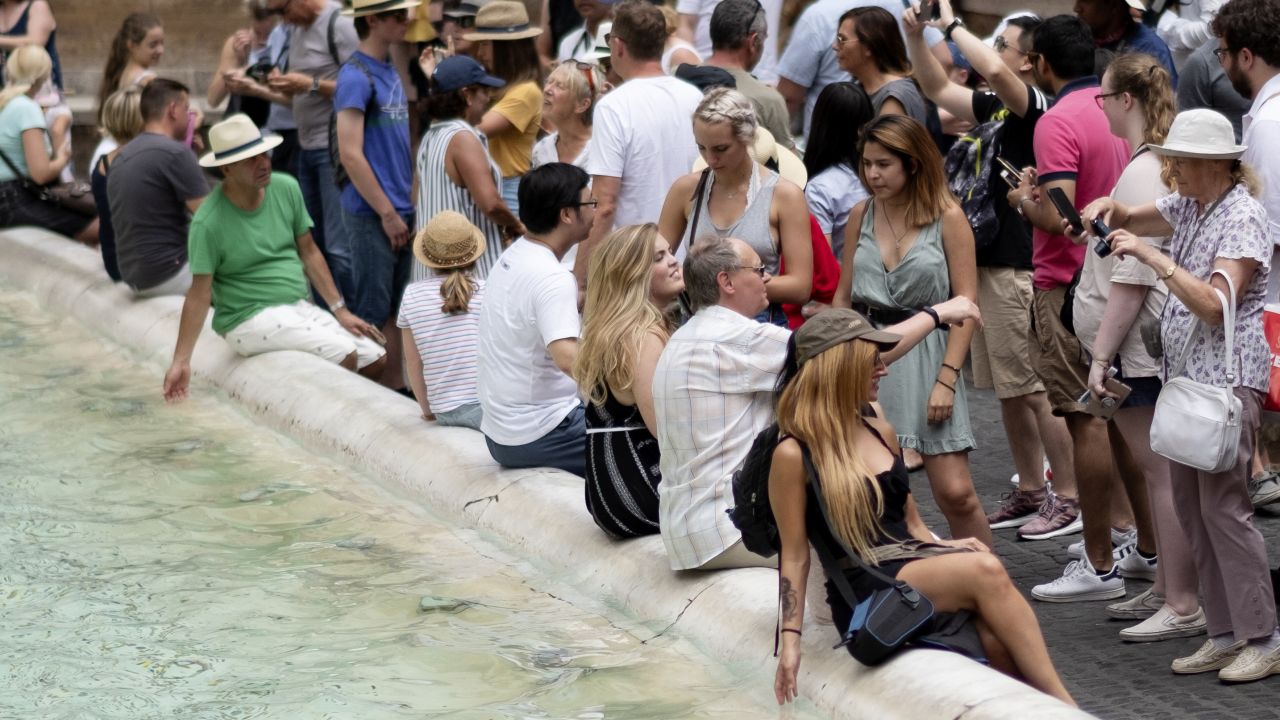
{"left": 396, "top": 210, "right": 485, "bottom": 430}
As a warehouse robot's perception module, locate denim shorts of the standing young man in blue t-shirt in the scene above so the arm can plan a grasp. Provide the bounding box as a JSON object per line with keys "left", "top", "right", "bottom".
{"left": 342, "top": 210, "right": 413, "bottom": 328}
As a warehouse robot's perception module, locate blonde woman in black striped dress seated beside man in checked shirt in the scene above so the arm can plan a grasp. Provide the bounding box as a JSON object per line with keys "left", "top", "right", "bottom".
{"left": 573, "top": 223, "right": 685, "bottom": 538}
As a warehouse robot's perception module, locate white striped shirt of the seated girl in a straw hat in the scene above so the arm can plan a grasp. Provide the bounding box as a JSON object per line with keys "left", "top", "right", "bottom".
{"left": 396, "top": 278, "right": 484, "bottom": 413}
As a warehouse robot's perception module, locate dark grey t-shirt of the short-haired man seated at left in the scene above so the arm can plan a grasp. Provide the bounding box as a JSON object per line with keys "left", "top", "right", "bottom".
{"left": 106, "top": 132, "right": 209, "bottom": 290}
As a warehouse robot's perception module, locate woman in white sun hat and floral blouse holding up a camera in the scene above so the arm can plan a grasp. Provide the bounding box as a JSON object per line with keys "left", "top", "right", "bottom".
{"left": 1082, "top": 109, "right": 1280, "bottom": 682}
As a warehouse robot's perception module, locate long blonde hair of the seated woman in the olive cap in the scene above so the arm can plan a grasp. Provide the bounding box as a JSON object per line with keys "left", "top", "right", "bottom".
{"left": 778, "top": 340, "right": 884, "bottom": 562}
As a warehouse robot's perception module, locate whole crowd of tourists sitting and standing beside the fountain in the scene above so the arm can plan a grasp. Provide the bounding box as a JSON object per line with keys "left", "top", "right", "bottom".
{"left": 0, "top": 0, "right": 1280, "bottom": 703}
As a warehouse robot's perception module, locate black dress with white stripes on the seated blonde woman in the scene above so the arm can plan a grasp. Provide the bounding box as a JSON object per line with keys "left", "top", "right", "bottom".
{"left": 586, "top": 392, "right": 662, "bottom": 538}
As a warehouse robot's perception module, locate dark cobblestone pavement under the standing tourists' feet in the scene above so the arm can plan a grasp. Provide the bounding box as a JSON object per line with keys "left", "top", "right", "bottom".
{"left": 911, "top": 384, "right": 1280, "bottom": 720}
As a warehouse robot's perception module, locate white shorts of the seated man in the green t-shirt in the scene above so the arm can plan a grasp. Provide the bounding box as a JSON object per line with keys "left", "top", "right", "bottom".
{"left": 227, "top": 300, "right": 387, "bottom": 369}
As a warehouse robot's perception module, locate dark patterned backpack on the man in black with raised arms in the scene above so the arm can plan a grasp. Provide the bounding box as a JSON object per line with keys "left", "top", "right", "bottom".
{"left": 943, "top": 120, "right": 1005, "bottom": 255}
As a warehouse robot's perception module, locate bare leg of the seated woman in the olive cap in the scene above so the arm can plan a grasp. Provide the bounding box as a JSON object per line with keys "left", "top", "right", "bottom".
{"left": 897, "top": 552, "right": 1075, "bottom": 706}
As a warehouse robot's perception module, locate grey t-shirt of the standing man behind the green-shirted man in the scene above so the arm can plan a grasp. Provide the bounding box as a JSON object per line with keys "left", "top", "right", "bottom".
{"left": 289, "top": 0, "right": 360, "bottom": 150}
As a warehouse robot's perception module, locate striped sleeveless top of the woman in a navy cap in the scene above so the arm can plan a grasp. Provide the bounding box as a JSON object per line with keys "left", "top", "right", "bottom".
{"left": 412, "top": 120, "right": 503, "bottom": 282}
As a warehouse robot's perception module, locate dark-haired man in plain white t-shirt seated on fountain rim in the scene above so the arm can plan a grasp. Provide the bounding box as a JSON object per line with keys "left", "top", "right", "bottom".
{"left": 477, "top": 163, "right": 595, "bottom": 477}
